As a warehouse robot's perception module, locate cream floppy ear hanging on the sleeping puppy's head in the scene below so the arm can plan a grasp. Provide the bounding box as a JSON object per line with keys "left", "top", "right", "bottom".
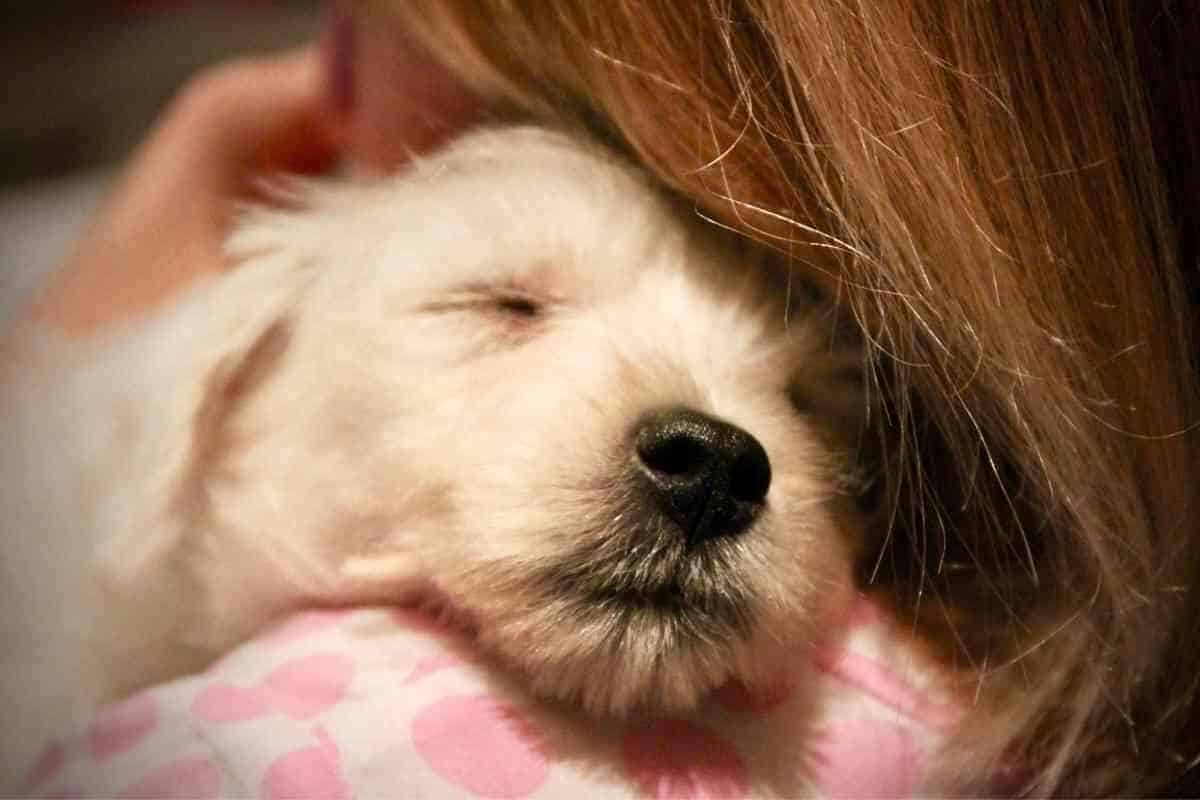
{"left": 84, "top": 309, "right": 292, "bottom": 690}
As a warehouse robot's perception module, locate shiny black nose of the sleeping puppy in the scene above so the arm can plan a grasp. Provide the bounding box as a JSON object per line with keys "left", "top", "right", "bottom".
{"left": 634, "top": 408, "right": 770, "bottom": 545}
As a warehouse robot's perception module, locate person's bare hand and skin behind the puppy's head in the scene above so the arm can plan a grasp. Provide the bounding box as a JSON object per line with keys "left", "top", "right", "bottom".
{"left": 30, "top": 1, "right": 476, "bottom": 337}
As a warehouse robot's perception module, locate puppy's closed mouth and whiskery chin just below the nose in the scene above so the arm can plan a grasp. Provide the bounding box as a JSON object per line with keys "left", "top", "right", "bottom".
{"left": 487, "top": 529, "right": 767, "bottom": 715}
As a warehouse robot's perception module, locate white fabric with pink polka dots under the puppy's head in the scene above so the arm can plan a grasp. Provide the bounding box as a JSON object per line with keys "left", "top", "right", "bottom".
{"left": 7, "top": 601, "right": 974, "bottom": 800}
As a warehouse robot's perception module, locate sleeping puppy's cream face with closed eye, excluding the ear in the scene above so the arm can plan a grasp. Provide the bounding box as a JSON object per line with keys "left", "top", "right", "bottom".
{"left": 223, "top": 132, "right": 863, "bottom": 712}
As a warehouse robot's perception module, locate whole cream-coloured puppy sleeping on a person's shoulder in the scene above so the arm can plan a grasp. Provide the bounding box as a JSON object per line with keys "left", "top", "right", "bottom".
{"left": 0, "top": 128, "right": 864, "bottom": 769}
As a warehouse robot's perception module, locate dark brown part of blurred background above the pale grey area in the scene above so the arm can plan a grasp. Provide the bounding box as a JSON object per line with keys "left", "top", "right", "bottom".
{"left": 0, "top": 0, "right": 322, "bottom": 185}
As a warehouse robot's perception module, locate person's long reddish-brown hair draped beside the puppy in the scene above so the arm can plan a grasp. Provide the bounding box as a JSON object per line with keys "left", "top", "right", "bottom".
{"left": 382, "top": 0, "right": 1200, "bottom": 794}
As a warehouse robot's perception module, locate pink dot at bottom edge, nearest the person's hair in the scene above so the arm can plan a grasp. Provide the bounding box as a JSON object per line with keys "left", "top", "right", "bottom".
{"left": 812, "top": 720, "right": 925, "bottom": 798}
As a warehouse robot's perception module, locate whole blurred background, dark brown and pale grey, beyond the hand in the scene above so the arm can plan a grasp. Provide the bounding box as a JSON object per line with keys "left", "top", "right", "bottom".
{"left": 0, "top": 0, "right": 323, "bottom": 321}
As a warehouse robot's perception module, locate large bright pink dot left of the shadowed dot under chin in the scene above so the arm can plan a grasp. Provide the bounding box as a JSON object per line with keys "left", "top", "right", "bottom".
{"left": 412, "top": 694, "right": 550, "bottom": 798}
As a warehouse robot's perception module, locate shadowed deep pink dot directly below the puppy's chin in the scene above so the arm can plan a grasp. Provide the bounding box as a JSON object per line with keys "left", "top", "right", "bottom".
{"left": 622, "top": 720, "right": 750, "bottom": 800}
